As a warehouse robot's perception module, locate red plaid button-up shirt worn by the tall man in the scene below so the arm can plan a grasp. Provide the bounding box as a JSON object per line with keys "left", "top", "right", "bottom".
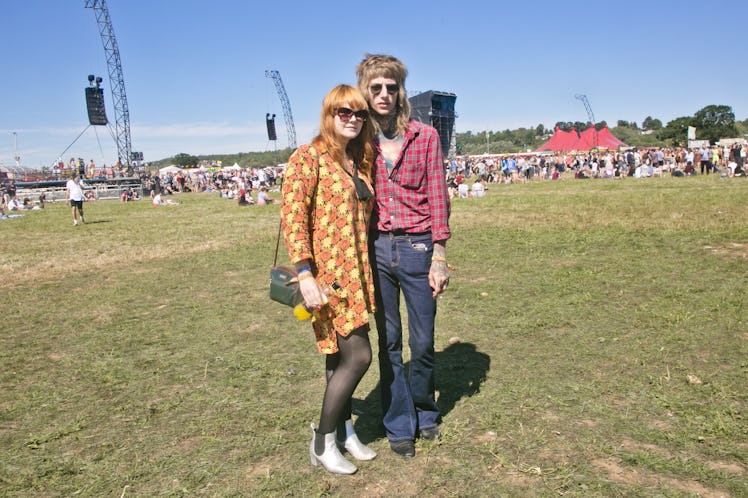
{"left": 372, "top": 119, "right": 451, "bottom": 242}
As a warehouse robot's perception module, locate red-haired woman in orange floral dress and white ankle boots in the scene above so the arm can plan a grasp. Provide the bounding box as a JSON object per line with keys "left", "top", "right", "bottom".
{"left": 281, "top": 85, "right": 377, "bottom": 474}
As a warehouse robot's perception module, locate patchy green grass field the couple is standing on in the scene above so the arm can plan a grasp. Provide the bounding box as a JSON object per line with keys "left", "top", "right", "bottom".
{"left": 0, "top": 177, "right": 748, "bottom": 497}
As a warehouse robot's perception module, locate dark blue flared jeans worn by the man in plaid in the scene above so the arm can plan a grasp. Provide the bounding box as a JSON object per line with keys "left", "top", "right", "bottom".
{"left": 372, "top": 233, "right": 441, "bottom": 441}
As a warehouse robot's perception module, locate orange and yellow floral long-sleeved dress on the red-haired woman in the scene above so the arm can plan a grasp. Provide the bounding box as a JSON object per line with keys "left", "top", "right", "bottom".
{"left": 281, "top": 145, "right": 375, "bottom": 354}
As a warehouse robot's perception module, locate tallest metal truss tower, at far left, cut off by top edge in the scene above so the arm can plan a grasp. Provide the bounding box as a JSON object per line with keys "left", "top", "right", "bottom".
{"left": 85, "top": 0, "right": 132, "bottom": 170}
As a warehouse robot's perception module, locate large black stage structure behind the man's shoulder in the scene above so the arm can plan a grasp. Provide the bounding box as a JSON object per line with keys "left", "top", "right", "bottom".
{"left": 408, "top": 90, "right": 457, "bottom": 158}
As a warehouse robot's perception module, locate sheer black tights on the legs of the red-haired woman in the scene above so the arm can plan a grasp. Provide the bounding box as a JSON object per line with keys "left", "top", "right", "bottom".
{"left": 317, "top": 327, "right": 371, "bottom": 437}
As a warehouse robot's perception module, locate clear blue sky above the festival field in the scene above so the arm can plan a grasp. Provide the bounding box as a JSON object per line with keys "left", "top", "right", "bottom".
{"left": 0, "top": 0, "right": 748, "bottom": 166}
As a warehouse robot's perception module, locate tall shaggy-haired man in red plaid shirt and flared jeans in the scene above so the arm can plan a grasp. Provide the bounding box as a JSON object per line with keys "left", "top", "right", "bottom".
{"left": 356, "top": 55, "right": 450, "bottom": 457}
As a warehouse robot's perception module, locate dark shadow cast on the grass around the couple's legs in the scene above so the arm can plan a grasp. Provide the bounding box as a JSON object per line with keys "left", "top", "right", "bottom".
{"left": 353, "top": 342, "right": 491, "bottom": 444}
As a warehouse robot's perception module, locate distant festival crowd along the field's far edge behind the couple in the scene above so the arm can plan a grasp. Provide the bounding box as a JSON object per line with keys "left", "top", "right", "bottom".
{"left": 142, "top": 144, "right": 748, "bottom": 206}
